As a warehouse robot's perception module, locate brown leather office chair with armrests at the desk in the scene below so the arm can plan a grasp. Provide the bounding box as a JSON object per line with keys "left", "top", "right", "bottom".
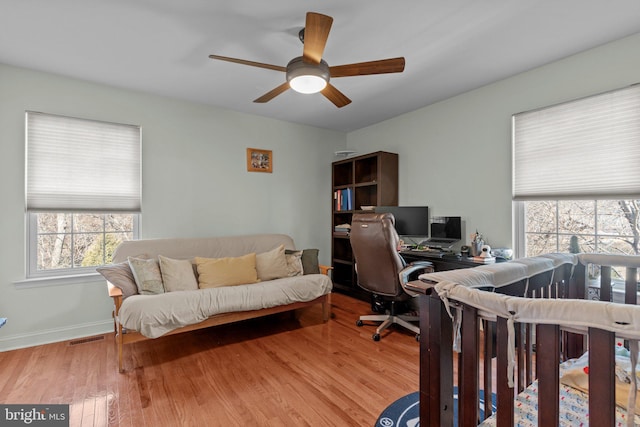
{"left": 350, "top": 213, "right": 433, "bottom": 341}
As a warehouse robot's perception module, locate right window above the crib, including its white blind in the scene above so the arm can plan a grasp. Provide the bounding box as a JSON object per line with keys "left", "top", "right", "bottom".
{"left": 512, "top": 85, "right": 640, "bottom": 264}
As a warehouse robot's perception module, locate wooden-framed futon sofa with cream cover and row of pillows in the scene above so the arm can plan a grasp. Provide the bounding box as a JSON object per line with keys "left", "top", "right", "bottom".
{"left": 97, "top": 234, "right": 332, "bottom": 372}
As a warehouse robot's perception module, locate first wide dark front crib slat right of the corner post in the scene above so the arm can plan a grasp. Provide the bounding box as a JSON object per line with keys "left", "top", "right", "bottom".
{"left": 458, "top": 306, "right": 480, "bottom": 427}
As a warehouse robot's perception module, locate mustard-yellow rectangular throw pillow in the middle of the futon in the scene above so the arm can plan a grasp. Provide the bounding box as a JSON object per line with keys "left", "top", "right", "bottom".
{"left": 195, "top": 253, "right": 258, "bottom": 289}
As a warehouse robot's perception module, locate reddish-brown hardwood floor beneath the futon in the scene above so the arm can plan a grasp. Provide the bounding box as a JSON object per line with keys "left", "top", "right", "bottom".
{"left": 0, "top": 293, "right": 419, "bottom": 427}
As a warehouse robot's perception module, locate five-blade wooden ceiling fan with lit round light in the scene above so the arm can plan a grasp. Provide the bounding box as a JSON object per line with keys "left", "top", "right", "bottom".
{"left": 209, "top": 12, "right": 404, "bottom": 108}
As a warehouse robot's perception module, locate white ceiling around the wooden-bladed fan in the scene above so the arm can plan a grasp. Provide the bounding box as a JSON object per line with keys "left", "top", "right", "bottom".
{"left": 0, "top": 0, "right": 640, "bottom": 131}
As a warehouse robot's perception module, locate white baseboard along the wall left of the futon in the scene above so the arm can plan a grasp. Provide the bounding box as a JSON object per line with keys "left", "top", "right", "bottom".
{"left": 0, "top": 320, "right": 113, "bottom": 351}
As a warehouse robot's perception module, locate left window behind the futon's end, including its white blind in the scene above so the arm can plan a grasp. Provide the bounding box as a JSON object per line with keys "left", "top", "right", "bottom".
{"left": 25, "top": 112, "right": 141, "bottom": 278}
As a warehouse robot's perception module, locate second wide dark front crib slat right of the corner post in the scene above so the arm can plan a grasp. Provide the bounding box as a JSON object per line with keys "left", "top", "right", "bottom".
{"left": 496, "top": 317, "right": 514, "bottom": 427}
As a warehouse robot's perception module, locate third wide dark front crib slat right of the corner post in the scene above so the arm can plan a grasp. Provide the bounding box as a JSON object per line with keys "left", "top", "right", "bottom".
{"left": 536, "top": 325, "right": 560, "bottom": 426}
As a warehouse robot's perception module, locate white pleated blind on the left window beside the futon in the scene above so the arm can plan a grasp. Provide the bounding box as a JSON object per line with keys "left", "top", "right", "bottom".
{"left": 26, "top": 111, "right": 141, "bottom": 212}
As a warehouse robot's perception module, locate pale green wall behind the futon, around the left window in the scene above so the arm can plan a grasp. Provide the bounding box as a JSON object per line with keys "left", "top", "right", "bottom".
{"left": 0, "top": 64, "right": 346, "bottom": 351}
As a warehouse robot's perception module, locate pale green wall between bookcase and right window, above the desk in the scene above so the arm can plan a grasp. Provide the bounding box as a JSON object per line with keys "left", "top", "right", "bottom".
{"left": 347, "top": 34, "right": 640, "bottom": 251}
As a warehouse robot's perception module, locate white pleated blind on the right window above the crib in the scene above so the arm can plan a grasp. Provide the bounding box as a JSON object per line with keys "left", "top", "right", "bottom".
{"left": 512, "top": 85, "right": 640, "bottom": 200}
